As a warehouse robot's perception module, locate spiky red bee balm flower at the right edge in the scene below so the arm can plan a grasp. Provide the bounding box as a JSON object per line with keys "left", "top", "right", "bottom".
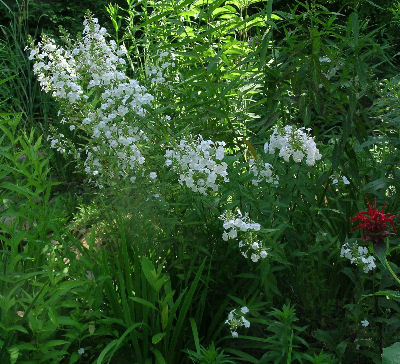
{"left": 351, "top": 197, "right": 399, "bottom": 243}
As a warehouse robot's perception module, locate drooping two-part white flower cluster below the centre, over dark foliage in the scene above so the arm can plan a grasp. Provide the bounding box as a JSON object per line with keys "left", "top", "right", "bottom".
{"left": 219, "top": 210, "right": 268, "bottom": 263}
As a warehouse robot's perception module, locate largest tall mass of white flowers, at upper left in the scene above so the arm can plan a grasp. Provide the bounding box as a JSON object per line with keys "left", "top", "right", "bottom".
{"left": 29, "top": 16, "right": 153, "bottom": 185}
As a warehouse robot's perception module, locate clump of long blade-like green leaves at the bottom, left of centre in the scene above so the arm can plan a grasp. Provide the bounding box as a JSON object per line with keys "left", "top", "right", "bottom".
{"left": 83, "top": 220, "right": 209, "bottom": 363}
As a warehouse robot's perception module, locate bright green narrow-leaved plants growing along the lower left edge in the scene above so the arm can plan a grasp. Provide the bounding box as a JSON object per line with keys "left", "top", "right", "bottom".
{"left": 0, "top": 113, "right": 95, "bottom": 364}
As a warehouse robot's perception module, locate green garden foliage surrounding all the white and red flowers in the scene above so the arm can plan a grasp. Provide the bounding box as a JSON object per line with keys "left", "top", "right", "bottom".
{"left": 0, "top": 0, "right": 400, "bottom": 363}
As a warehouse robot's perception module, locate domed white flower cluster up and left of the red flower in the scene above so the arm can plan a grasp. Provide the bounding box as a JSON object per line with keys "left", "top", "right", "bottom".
{"left": 264, "top": 125, "right": 322, "bottom": 166}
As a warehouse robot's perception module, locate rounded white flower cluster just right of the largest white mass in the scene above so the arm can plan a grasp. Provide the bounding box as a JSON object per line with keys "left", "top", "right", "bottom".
{"left": 165, "top": 135, "right": 229, "bottom": 195}
